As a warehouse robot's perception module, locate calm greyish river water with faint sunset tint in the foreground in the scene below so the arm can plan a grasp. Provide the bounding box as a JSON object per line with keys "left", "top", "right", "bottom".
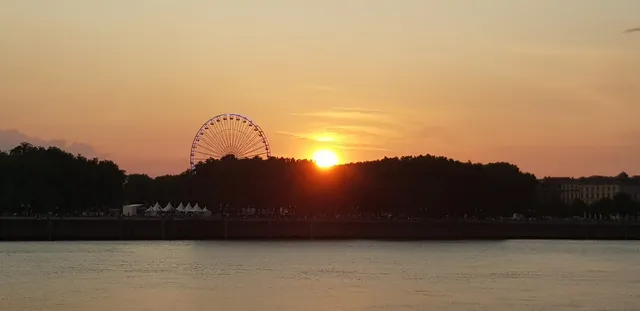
{"left": 0, "top": 241, "right": 640, "bottom": 311}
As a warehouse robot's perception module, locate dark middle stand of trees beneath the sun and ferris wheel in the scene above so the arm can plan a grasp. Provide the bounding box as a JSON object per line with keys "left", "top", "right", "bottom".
{"left": 126, "top": 156, "right": 537, "bottom": 218}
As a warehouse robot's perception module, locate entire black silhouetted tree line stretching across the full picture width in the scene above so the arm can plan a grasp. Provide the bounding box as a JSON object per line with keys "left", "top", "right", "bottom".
{"left": 0, "top": 143, "right": 638, "bottom": 219}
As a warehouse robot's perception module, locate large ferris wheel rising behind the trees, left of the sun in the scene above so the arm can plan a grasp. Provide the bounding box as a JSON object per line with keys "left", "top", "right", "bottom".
{"left": 190, "top": 113, "right": 271, "bottom": 170}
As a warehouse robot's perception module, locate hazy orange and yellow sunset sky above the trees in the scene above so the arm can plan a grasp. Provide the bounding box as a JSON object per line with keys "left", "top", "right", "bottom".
{"left": 0, "top": 0, "right": 640, "bottom": 177}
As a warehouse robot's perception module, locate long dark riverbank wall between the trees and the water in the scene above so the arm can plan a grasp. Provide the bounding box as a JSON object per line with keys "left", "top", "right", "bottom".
{"left": 0, "top": 218, "right": 640, "bottom": 241}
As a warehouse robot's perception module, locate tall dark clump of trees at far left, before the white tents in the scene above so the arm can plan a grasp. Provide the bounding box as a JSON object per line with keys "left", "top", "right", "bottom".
{"left": 0, "top": 143, "right": 126, "bottom": 215}
